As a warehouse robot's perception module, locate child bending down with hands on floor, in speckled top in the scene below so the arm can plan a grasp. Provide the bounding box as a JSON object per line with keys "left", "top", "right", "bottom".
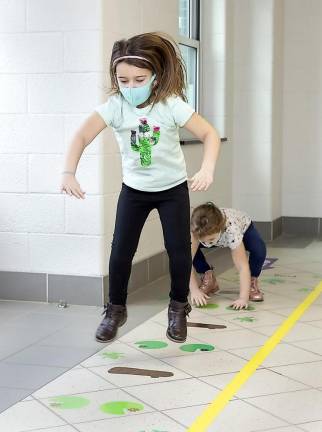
{"left": 190, "top": 202, "right": 266, "bottom": 309}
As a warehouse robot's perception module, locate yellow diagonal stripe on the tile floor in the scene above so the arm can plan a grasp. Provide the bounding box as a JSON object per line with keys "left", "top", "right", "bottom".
{"left": 188, "top": 281, "right": 322, "bottom": 432}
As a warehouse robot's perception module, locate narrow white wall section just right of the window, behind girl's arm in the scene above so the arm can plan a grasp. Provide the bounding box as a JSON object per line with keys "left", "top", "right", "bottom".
{"left": 197, "top": 0, "right": 233, "bottom": 207}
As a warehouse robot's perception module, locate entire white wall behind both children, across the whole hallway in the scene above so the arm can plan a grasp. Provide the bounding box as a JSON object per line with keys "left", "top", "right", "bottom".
{"left": 0, "top": 0, "right": 316, "bottom": 275}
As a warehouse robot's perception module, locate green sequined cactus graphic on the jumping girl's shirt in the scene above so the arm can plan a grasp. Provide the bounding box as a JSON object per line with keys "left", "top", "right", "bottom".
{"left": 131, "top": 118, "right": 160, "bottom": 166}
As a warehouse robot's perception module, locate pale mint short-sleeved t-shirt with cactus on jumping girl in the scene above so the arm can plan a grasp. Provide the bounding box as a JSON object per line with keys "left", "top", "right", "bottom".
{"left": 95, "top": 94, "right": 194, "bottom": 192}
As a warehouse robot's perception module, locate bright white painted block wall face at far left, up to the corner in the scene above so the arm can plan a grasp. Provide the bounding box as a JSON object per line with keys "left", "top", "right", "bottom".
{"left": 0, "top": 0, "right": 105, "bottom": 275}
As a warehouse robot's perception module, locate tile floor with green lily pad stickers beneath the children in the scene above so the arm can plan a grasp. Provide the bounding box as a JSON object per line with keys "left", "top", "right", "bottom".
{"left": 0, "top": 241, "right": 322, "bottom": 432}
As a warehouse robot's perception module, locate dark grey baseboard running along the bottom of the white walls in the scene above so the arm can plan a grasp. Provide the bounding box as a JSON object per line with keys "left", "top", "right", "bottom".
{"left": 0, "top": 216, "right": 322, "bottom": 306}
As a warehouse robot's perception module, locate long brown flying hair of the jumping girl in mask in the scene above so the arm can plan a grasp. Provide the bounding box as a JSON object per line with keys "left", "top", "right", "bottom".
{"left": 110, "top": 32, "right": 187, "bottom": 104}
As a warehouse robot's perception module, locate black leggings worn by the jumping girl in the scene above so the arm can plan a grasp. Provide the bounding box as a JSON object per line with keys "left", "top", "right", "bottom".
{"left": 109, "top": 182, "right": 192, "bottom": 305}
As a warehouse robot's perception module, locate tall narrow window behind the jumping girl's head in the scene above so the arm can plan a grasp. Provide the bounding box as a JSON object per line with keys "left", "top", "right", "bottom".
{"left": 179, "top": 0, "right": 200, "bottom": 111}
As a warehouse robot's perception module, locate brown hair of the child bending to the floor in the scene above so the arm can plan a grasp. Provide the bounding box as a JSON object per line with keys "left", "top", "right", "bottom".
{"left": 190, "top": 202, "right": 226, "bottom": 238}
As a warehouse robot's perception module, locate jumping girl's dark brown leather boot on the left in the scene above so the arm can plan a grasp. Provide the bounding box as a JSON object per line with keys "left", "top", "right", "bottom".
{"left": 96, "top": 303, "right": 127, "bottom": 342}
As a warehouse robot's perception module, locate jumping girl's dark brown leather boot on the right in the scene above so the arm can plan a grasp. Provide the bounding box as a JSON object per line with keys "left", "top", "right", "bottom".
{"left": 167, "top": 300, "right": 191, "bottom": 343}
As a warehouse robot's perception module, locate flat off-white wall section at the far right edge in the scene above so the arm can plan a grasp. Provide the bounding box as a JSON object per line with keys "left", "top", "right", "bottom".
{"left": 282, "top": 0, "right": 322, "bottom": 217}
